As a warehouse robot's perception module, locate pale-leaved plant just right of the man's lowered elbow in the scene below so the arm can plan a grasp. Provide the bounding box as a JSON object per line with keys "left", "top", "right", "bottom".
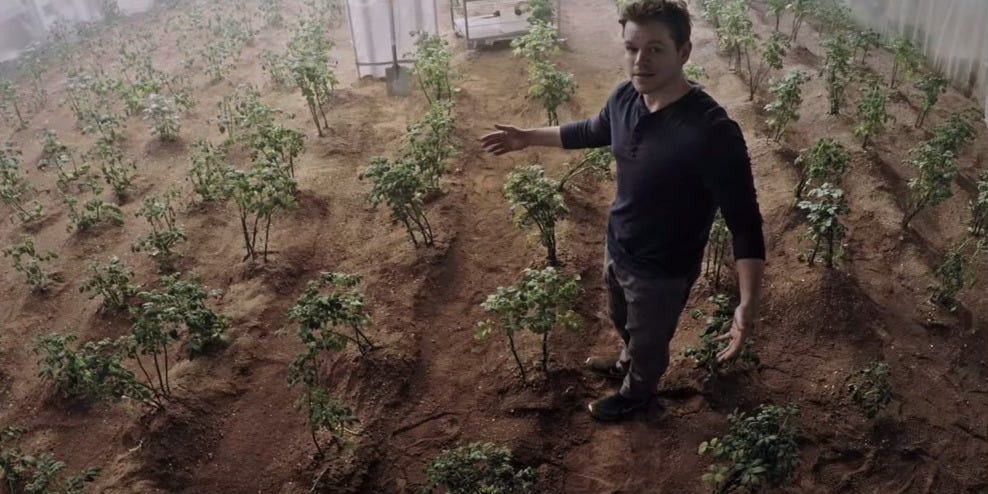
{"left": 798, "top": 183, "right": 850, "bottom": 268}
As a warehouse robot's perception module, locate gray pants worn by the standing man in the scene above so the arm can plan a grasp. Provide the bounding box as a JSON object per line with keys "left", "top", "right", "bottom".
{"left": 604, "top": 248, "right": 700, "bottom": 398}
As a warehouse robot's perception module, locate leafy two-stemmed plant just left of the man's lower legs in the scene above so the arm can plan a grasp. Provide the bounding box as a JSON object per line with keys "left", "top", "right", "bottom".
{"left": 474, "top": 266, "right": 583, "bottom": 383}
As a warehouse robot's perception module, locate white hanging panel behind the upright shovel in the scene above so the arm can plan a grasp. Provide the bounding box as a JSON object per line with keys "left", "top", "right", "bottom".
{"left": 347, "top": 0, "right": 438, "bottom": 78}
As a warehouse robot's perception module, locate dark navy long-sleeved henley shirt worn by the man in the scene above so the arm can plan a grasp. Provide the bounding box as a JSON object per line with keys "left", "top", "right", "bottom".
{"left": 560, "top": 81, "right": 765, "bottom": 278}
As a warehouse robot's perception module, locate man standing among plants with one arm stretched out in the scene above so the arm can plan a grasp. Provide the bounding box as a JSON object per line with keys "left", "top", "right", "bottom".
{"left": 481, "top": 0, "right": 765, "bottom": 420}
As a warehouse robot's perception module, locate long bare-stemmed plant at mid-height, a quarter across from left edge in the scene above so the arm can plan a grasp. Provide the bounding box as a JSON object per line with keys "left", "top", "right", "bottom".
{"left": 224, "top": 156, "right": 298, "bottom": 262}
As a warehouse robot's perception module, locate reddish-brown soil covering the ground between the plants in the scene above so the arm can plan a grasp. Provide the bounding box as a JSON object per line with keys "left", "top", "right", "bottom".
{"left": 0, "top": 0, "right": 988, "bottom": 494}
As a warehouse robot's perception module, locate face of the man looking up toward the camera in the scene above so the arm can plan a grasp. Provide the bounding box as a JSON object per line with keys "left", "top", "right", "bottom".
{"left": 624, "top": 21, "right": 692, "bottom": 94}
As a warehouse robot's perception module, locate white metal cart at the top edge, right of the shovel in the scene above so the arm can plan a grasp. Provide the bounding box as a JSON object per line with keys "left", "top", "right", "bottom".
{"left": 449, "top": 0, "right": 562, "bottom": 49}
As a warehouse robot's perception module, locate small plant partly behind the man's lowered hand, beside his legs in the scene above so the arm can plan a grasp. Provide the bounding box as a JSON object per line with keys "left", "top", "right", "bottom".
{"left": 683, "top": 294, "right": 758, "bottom": 380}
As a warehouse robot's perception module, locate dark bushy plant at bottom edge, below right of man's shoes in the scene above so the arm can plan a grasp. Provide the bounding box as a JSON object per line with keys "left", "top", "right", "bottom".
{"left": 698, "top": 405, "right": 800, "bottom": 494}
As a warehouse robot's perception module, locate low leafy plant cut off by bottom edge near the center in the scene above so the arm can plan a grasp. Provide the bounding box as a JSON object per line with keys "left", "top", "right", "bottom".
{"left": 424, "top": 443, "right": 538, "bottom": 494}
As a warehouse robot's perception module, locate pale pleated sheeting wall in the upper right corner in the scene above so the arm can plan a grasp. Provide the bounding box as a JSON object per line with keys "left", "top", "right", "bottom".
{"left": 848, "top": 0, "right": 988, "bottom": 120}
